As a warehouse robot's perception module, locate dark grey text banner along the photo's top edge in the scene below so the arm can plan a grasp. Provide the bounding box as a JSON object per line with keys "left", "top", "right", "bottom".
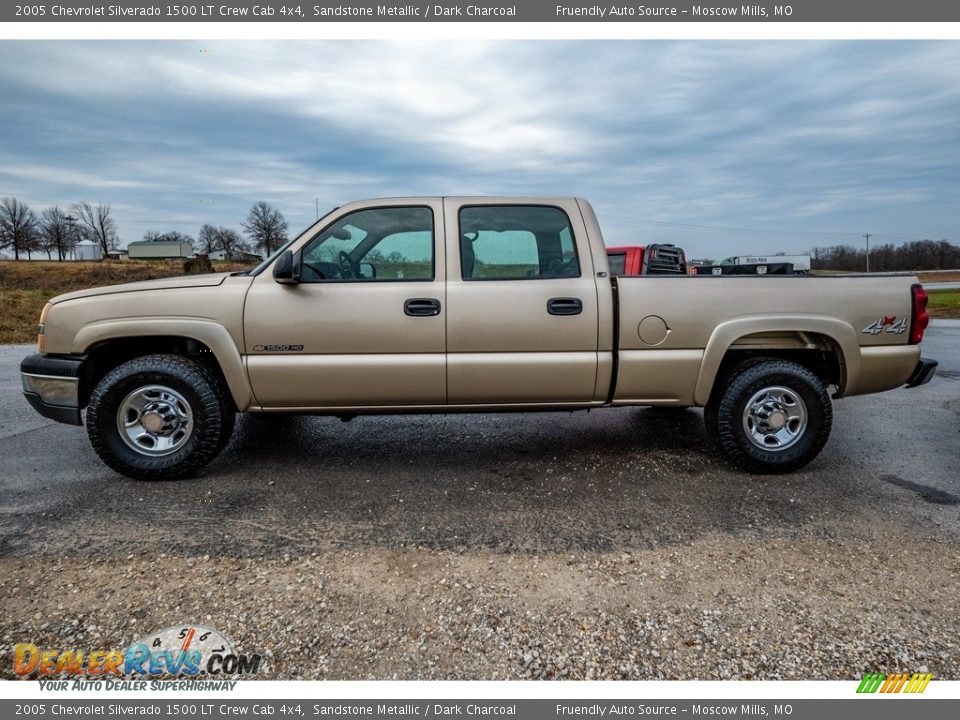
{"left": 0, "top": 0, "right": 960, "bottom": 23}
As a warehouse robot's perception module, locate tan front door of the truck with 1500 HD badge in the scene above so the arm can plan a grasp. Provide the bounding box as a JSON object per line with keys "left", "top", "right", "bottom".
{"left": 244, "top": 200, "right": 447, "bottom": 409}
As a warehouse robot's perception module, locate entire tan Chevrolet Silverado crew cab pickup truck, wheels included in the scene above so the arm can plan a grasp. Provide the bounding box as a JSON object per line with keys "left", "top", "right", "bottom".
{"left": 21, "top": 197, "right": 936, "bottom": 480}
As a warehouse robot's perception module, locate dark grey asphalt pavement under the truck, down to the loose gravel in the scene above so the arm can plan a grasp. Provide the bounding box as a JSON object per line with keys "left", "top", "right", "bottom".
{"left": 0, "top": 321, "right": 960, "bottom": 556}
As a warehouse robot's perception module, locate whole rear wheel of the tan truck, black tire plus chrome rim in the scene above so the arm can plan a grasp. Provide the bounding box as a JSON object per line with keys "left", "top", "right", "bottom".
{"left": 704, "top": 358, "right": 833, "bottom": 473}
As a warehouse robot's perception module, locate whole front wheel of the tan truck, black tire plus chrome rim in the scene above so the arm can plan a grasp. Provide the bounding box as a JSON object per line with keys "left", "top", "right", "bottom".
{"left": 86, "top": 355, "right": 235, "bottom": 480}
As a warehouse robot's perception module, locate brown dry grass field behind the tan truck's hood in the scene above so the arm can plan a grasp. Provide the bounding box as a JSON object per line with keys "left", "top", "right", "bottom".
{"left": 0, "top": 260, "right": 251, "bottom": 344}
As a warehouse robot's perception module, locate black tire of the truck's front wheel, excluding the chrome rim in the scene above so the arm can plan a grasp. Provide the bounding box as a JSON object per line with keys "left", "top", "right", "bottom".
{"left": 86, "top": 354, "right": 236, "bottom": 480}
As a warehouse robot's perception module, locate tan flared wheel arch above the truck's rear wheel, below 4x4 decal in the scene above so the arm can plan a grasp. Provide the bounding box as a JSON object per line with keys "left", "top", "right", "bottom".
{"left": 694, "top": 315, "right": 860, "bottom": 405}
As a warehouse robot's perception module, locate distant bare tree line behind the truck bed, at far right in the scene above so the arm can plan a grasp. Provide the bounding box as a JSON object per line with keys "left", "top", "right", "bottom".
{"left": 810, "top": 240, "right": 960, "bottom": 272}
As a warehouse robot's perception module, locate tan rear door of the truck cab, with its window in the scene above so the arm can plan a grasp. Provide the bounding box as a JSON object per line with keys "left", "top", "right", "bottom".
{"left": 444, "top": 198, "right": 599, "bottom": 405}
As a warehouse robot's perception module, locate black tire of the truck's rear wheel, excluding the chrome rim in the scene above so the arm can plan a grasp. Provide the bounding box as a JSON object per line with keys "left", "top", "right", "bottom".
{"left": 704, "top": 358, "right": 833, "bottom": 474}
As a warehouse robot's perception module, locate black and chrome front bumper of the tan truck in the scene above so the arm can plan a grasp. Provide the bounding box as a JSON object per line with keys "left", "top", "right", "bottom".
{"left": 20, "top": 353, "right": 86, "bottom": 425}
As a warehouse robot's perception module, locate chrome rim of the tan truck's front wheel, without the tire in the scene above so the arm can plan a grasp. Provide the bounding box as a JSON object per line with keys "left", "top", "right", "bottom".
{"left": 117, "top": 385, "right": 193, "bottom": 457}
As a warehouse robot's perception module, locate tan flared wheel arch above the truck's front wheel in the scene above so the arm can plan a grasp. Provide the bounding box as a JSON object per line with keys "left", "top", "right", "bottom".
{"left": 73, "top": 318, "right": 253, "bottom": 411}
